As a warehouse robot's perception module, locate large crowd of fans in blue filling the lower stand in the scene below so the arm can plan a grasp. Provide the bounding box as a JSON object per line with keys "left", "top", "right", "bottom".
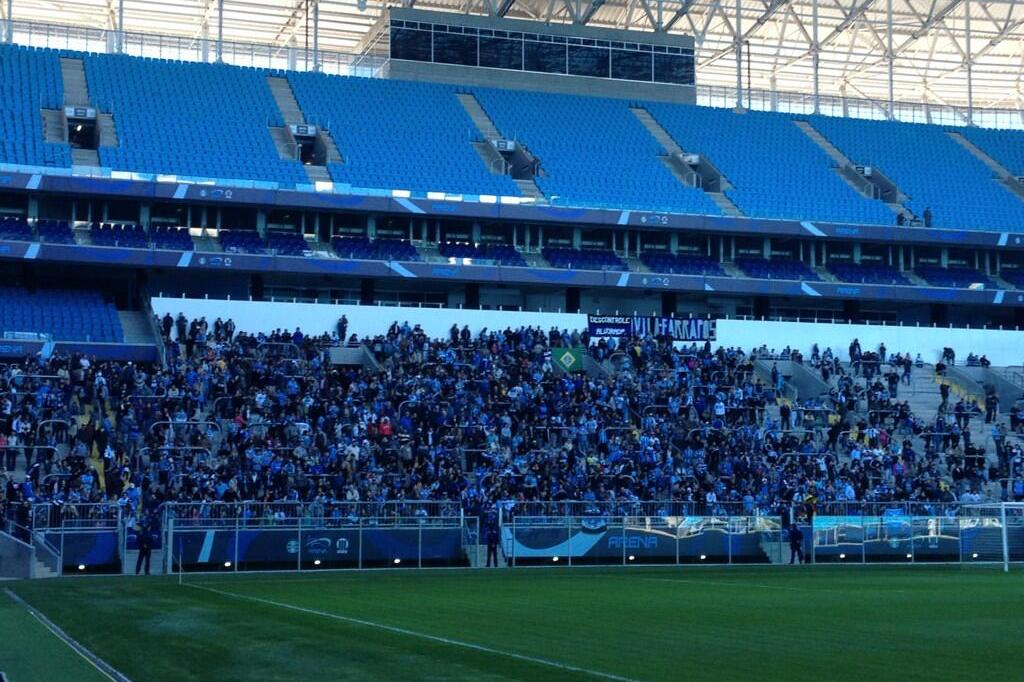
{"left": 0, "top": 315, "right": 1024, "bottom": 522}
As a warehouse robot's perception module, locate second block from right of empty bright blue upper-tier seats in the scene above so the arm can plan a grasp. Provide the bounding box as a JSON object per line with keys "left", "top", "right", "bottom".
{"left": 813, "top": 117, "right": 1024, "bottom": 231}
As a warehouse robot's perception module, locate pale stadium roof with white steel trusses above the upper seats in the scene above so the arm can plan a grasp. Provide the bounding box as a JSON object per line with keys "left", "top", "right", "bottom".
{"left": 0, "top": 0, "right": 1024, "bottom": 120}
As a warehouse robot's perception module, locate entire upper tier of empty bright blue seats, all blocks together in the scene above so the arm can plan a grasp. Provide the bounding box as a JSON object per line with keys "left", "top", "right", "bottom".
{"left": 0, "top": 45, "right": 1024, "bottom": 231}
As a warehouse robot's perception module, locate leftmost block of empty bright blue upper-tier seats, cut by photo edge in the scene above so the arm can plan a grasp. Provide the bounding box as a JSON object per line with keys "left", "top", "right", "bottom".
{"left": 0, "top": 45, "right": 71, "bottom": 168}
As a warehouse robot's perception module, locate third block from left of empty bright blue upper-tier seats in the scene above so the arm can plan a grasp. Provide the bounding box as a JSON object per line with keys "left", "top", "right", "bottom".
{"left": 288, "top": 73, "right": 519, "bottom": 197}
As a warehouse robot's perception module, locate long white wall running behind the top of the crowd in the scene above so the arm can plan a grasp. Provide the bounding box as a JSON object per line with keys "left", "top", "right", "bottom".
{"left": 153, "top": 297, "right": 1024, "bottom": 366}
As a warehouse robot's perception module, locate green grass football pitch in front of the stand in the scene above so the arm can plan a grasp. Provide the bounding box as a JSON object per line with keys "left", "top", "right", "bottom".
{"left": 0, "top": 566, "right": 1024, "bottom": 682}
